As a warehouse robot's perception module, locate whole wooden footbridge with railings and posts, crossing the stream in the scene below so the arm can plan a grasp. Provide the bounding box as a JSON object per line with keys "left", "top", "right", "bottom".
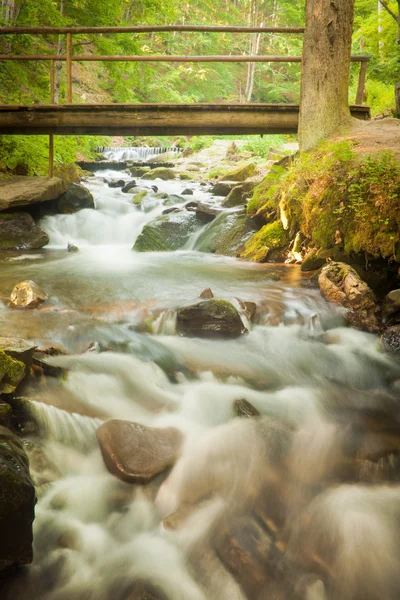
{"left": 0, "top": 25, "right": 370, "bottom": 171}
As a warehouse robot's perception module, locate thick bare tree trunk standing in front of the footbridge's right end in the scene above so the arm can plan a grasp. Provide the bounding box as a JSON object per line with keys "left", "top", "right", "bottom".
{"left": 299, "top": 0, "right": 354, "bottom": 150}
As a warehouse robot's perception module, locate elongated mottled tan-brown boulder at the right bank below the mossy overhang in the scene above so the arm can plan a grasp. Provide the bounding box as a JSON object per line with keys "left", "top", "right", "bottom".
{"left": 318, "top": 262, "right": 379, "bottom": 332}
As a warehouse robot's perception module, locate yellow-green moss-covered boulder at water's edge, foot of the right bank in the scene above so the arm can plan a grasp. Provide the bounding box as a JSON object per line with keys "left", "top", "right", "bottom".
{"left": 240, "top": 221, "right": 289, "bottom": 262}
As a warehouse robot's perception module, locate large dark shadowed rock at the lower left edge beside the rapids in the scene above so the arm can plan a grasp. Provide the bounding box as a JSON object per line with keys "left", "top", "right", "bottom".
{"left": 0, "top": 427, "right": 36, "bottom": 575}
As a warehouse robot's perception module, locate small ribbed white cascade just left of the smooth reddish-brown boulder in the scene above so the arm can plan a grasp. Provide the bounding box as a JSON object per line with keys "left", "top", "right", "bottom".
{"left": 29, "top": 400, "right": 103, "bottom": 450}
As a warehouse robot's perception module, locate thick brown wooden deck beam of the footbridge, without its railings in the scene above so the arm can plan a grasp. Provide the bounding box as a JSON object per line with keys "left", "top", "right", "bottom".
{"left": 0, "top": 104, "right": 370, "bottom": 135}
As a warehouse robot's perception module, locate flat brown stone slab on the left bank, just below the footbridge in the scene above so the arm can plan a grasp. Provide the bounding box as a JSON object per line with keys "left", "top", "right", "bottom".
{"left": 0, "top": 177, "right": 66, "bottom": 211}
